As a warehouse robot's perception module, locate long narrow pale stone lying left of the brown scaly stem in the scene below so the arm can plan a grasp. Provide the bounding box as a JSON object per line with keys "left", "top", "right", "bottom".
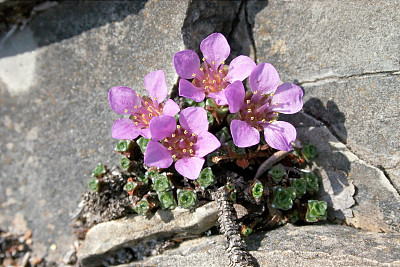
{"left": 78, "top": 202, "right": 218, "bottom": 266}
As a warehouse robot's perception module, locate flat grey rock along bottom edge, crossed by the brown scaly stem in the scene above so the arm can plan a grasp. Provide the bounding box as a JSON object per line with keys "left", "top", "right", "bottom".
{"left": 116, "top": 225, "right": 400, "bottom": 267}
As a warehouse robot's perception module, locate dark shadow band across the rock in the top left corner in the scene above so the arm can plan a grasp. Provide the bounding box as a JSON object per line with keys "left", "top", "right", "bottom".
{"left": 2, "top": 0, "right": 147, "bottom": 56}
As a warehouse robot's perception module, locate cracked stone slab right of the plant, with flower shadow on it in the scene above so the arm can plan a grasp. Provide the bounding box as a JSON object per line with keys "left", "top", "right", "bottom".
{"left": 285, "top": 113, "right": 400, "bottom": 232}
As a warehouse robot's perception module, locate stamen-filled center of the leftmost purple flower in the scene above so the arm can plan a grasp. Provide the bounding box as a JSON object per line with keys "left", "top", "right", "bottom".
{"left": 130, "top": 94, "right": 164, "bottom": 129}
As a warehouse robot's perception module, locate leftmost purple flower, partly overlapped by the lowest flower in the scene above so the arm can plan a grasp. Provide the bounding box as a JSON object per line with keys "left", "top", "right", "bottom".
{"left": 108, "top": 70, "right": 179, "bottom": 139}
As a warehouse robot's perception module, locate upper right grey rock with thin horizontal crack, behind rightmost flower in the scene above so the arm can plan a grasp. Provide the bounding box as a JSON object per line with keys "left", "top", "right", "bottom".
{"left": 254, "top": 1, "right": 400, "bottom": 192}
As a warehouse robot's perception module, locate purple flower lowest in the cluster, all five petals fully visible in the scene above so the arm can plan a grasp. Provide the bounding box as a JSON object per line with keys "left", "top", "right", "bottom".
{"left": 144, "top": 107, "right": 221, "bottom": 180}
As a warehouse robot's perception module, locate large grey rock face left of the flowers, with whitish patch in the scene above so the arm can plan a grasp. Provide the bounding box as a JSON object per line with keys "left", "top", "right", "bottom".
{"left": 0, "top": 1, "right": 188, "bottom": 260}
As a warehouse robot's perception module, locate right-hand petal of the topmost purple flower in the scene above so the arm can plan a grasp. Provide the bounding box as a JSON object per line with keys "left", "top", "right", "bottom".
{"left": 225, "top": 56, "right": 256, "bottom": 83}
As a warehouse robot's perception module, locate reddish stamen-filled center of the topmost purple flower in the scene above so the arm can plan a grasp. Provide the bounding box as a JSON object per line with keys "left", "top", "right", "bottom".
{"left": 192, "top": 58, "right": 229, "bottom": 95}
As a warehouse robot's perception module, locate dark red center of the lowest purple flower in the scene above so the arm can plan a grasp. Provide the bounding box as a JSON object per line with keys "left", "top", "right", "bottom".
{"left": 161, "top": 125, "right": 197, "bottom": 159}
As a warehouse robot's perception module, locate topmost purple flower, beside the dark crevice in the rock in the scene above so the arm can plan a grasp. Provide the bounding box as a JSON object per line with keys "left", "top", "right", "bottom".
{"left": 174, "top": 33, "right": 256, "bottom": 105}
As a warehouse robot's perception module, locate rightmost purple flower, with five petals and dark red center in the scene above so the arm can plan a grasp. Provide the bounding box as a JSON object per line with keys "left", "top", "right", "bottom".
{"left": 225, "top": 63, "right": 303, "bottom": 151}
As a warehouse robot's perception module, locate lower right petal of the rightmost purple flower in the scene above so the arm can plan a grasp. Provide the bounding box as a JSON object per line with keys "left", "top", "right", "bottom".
{"left": 264, "top": 121, "right": 297, "bottom": 151}
